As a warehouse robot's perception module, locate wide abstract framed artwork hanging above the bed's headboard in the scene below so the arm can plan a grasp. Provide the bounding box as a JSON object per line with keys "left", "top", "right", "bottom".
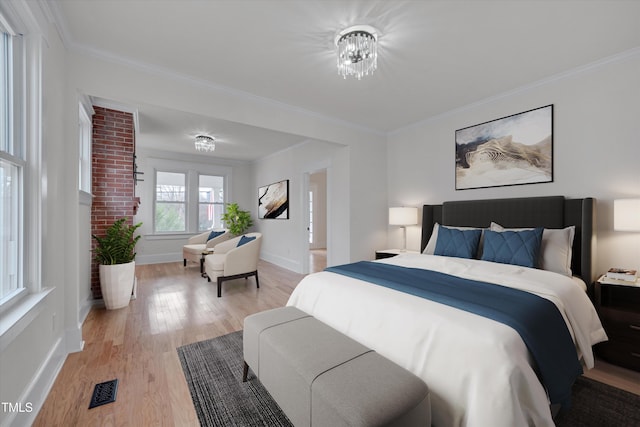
{"left": 455, "top": 104, "right": 553, "bottom": 190}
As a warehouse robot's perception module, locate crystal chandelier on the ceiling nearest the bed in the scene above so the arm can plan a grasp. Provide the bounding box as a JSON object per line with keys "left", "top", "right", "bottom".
{"left": 335, "top": 25, "right": 378, "bottom": 80}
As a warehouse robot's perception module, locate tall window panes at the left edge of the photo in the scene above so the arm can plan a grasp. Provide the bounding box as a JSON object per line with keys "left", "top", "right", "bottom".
{"left": 0, "top": 30, "right": 26, "bottom": 305}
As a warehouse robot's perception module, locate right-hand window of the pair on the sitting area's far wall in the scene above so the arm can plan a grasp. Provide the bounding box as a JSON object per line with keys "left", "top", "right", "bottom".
{"left": 198, "top": 175, "right": 224, "bottom": 231}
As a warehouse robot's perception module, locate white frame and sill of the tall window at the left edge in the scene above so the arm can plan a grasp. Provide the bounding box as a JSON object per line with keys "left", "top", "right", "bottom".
{"left": 0, "top": 2, "right": 47, "bottom": 332}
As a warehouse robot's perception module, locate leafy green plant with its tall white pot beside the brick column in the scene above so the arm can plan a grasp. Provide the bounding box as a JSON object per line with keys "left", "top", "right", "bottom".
{"left": 92, "top": 218, "right": 142, "bottom": 310}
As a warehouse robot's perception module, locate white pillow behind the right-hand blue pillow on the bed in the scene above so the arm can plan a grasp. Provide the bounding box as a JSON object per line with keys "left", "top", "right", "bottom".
{"left": 489, "top": 222, "right": 576, "bottom": 277}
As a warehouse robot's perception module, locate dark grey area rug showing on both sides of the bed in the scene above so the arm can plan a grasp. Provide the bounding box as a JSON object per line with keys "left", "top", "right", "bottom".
{"left": 178, "top": 331, "right": 640, "bottom": 427}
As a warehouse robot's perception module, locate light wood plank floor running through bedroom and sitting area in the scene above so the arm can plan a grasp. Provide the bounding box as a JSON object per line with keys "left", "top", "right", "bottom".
{"left": 34, "top": 253, "right": 640, "bottom": 427}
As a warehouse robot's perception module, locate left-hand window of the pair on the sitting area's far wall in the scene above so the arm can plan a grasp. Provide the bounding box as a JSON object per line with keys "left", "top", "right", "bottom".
{"left": 154, "top": 171, "right": 187, "bottom": 233}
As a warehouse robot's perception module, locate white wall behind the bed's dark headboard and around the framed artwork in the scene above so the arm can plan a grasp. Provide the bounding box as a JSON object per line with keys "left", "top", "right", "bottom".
{"left": 387, "top": 50, "right": 640, "bottom": 278}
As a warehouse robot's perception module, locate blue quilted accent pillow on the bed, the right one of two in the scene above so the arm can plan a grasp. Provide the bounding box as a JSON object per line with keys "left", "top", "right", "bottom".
{"left": 482, "top": 228, "right": 543, "bottom": 268}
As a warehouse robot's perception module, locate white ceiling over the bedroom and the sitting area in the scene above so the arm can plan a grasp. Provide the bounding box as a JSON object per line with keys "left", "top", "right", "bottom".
{"left": 52, "top": 0, "right": 640, "bottom": 160}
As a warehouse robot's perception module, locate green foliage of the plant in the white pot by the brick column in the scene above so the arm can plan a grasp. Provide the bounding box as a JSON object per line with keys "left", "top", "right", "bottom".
{"left": 92, "top": 218, "right": 142, "bottom": 265}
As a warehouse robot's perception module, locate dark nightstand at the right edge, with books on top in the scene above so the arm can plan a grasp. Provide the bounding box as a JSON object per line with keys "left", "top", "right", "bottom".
{"left": 594, "top": 279, "right": 640, "bottom": 371}
